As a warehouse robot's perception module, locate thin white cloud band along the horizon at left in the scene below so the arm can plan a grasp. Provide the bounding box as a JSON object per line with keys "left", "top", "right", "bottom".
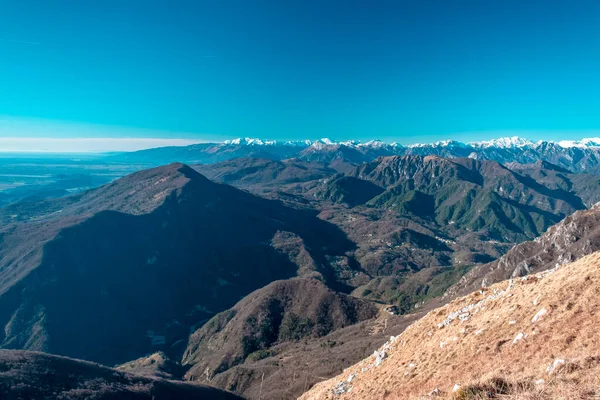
{"left": 0, "top": 137, "right": 202, "bottom": 153}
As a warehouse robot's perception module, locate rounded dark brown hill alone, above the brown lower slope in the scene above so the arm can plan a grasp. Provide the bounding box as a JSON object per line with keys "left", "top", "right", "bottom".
{"left": 183, "top": 278, "right": 378, "bottom": 381}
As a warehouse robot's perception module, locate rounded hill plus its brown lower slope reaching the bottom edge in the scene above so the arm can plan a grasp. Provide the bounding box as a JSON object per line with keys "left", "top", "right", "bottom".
{"left": 183, "top": 278, "right": 426, "bottom": 399}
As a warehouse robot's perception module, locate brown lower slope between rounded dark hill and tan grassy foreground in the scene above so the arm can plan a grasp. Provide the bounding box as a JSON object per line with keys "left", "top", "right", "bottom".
{"left": 200, "top": 311, "right": 423, "bottom": 400}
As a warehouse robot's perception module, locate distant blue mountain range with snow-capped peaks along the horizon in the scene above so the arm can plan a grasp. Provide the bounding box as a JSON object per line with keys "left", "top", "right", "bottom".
{"left": 120, "top": 136, "right": 600, "bottom": 172}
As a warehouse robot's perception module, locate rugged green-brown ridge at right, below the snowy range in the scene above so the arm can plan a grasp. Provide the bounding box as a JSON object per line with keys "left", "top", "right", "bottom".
{"left": 352, "top": 156, "right": 598, "bottom": 241}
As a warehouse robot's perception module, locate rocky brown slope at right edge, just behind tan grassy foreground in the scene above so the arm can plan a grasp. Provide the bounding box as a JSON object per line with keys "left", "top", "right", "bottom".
{"left": 446, "top": 204, "right": 600, "bottom": 297}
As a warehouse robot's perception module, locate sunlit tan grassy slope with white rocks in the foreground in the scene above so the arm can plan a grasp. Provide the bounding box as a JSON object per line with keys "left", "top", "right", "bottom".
{"left": 301, "top": 253, "right": 600, "bottom": 400}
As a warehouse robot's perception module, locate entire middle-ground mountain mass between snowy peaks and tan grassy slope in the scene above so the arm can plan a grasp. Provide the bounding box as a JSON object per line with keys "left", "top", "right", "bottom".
{"left": 0, "top": 148, "right": 600, "bottom": 399}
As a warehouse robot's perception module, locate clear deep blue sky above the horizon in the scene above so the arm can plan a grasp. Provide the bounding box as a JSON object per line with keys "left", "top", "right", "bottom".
{"left": 0, "top": 0, "right": 600, "bottom": 150}
